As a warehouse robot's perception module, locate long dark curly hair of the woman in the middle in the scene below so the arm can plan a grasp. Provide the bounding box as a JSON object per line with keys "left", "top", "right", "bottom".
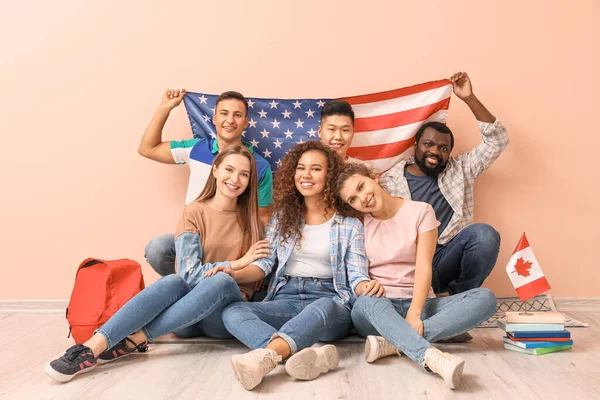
{"left": 273, "top": 140, "right": 342, "bottom": 243}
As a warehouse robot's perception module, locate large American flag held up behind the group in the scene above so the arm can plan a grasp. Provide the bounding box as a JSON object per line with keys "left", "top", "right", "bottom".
{"left": 184, "top": 79, "right": 452, "bottom": 171}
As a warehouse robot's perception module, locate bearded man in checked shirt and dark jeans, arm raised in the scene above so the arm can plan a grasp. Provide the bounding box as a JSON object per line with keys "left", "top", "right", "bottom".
{"left": 380, "top": 72, "right": 509, "bottom": 294}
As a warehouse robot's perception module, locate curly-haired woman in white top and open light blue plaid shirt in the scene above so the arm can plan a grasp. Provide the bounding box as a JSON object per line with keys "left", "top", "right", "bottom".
{"left": 214, "top": 141, "right": 372, "bottom": 390}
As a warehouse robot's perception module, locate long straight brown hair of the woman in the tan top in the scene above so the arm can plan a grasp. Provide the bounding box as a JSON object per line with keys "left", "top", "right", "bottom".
{"left": 196, "top": 146, "right": 264, "bottom": 255}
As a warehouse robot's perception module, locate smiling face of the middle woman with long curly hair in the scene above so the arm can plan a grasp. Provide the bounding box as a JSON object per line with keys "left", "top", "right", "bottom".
{"left": 294, "top": 150, "right": 327, "bottom": 199}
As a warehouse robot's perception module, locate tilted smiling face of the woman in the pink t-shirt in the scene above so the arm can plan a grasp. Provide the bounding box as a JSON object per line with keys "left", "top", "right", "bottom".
{"left": 339, "top": 174, "right": 383, "bottom": 213}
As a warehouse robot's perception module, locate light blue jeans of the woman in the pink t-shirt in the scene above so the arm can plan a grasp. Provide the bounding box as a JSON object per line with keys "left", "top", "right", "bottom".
{"left": 352, "top": 288, "right": 496, "bottom": 365}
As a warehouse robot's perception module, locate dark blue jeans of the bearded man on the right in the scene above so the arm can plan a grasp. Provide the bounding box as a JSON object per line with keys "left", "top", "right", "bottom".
{"left": 431, "top": 224, "right": 500, "bottom": 294}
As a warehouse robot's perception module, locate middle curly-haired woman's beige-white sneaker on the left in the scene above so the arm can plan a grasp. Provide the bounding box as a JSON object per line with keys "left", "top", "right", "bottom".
{"left": 231, "top": 349, "right": 281, "bottom": 390}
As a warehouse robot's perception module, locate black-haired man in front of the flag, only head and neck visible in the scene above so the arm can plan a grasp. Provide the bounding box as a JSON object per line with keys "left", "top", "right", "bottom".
{"left": 318, "top": 100, "right": 360, "bottom": 161}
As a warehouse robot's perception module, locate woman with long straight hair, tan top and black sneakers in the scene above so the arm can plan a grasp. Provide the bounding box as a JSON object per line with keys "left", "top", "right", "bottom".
{"left": 44, "top": 146, "right": 270, "bottom": 382}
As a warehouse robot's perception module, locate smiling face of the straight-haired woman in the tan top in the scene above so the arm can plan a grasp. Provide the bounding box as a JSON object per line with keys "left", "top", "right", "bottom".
{"left": 213, "top": 154, "right": 250, "bottom": 199}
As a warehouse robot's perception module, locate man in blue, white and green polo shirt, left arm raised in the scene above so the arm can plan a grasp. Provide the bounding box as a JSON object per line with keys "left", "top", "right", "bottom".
{"left": 138, "top": 89, "right": 273, "bottom": 276}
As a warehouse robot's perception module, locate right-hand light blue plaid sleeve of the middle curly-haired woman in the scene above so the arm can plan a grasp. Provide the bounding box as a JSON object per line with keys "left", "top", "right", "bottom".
{"left": 344, "top": 218, "right": 370, "bottom": 293}
